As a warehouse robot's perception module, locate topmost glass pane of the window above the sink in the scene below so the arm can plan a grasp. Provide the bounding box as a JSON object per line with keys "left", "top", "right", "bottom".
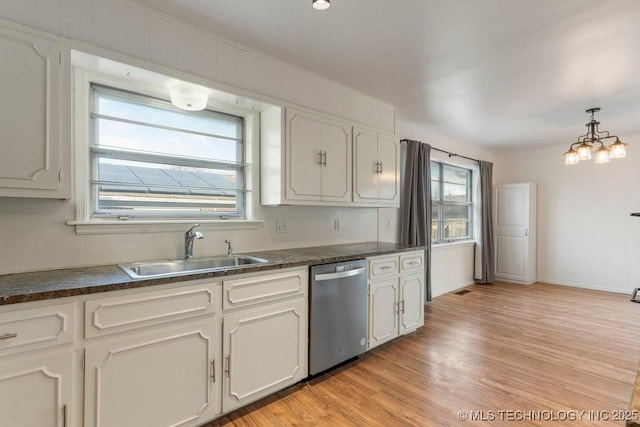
{"left": 96, "top": 88, "right": 242, "bottom": 138}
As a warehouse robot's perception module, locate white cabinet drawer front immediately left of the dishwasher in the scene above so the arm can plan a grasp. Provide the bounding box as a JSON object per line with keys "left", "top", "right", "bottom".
{"left": 222, "top": 269, "right": 309, "bottom": 310}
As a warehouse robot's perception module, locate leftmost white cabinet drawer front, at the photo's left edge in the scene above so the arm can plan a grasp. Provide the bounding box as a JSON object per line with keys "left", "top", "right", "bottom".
{"left": 0, "top": 303, "right": 75, "bottom": 354}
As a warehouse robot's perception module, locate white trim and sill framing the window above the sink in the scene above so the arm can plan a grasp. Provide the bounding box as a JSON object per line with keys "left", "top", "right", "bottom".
{"left": 72, "top": 57, "right": 264, "bottom": 234}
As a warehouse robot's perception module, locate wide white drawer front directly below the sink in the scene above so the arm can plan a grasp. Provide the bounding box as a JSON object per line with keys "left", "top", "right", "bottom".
{"left": 85, "top": 283, "right": 219, "bottom": 338}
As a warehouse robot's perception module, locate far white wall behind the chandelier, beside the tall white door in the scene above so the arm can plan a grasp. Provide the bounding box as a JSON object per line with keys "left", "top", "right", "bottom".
{"left": 495, "top": 135, "right": 640, "bottom": 293}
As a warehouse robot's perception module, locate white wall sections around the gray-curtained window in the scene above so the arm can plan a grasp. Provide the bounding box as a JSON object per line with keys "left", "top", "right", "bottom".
{"left": 378, "top": 120, "right": 502, "bottom": 297}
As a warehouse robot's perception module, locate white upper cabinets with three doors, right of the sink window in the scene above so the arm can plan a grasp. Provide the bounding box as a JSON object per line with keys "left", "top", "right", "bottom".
{"left": 261, "top": 107, "right": 400, "bottom": 207}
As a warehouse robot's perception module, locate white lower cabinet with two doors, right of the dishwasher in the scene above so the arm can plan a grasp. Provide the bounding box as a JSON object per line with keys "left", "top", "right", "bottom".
{"left": 368, "top": 251, "right": 425, "bottom": 349}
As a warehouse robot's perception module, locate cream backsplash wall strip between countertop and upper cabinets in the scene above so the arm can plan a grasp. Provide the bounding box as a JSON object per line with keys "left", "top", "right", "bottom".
{"left": 0, "top": 198, "right": 377, "bottom": 274}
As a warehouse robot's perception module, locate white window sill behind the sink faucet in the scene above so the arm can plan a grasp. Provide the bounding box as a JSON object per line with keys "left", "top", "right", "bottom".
{"left": 67, "top": 219, "right": 264, "bottom": 234}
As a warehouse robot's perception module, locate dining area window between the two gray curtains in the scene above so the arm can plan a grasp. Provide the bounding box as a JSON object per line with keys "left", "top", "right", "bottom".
{"left": 431, "top": 161, "right": 473, "bottom": 243}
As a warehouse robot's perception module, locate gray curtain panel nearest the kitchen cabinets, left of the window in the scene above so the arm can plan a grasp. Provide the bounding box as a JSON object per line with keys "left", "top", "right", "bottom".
{"left": 400, "top": 139, "right": 431, "bottom": 301}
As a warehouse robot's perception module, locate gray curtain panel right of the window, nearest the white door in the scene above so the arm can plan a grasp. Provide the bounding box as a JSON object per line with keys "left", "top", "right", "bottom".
{"left": 477, "top": 160, "right": 496, "bottom": 283}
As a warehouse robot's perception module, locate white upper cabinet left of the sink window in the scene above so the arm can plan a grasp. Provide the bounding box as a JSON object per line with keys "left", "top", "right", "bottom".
{"left": 0, "top": 21, "right": 71, "bottom": 199}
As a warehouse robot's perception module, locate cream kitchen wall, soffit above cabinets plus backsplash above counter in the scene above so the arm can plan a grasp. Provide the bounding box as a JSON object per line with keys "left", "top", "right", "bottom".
{"left": 0, "top": 0, "right": 388, "bottom": 274}
